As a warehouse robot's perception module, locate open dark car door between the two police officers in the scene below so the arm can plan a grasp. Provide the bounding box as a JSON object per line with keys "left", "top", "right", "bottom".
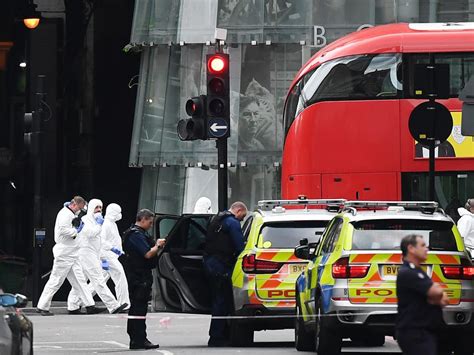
{"left": 152, "top": 214, "right": 212, "bottom": 313}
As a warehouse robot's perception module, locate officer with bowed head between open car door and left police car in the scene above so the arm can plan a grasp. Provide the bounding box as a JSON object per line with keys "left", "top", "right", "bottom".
{"left": 204, "top": 201, "right": 247, "bottom": 347}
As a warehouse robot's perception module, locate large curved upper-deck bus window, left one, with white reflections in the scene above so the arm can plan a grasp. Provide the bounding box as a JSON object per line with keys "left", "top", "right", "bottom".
{"left": 302, "top": 54, "right": 402, "bottom": 106}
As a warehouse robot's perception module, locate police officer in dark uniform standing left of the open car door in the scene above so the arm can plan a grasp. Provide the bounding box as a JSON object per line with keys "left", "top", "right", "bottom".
{"left": 123, "top": 209, "right": 165, "bottom": 349}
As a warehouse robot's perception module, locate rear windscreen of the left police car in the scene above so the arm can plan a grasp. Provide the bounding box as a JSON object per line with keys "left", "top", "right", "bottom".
{"left": 259, "top": 221, "right": 327, "bottom": 248}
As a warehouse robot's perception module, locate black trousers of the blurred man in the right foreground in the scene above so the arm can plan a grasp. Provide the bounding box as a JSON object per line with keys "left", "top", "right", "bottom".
{"left": 397, "top": 328, "right": 437, "bottom": 355}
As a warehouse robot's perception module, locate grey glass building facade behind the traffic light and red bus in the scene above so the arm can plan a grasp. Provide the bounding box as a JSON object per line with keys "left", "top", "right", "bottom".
{"left": 129, "top": 0, "right": 474, "bottom": 213}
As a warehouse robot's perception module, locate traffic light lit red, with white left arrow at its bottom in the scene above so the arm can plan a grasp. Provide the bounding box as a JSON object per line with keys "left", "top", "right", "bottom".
{"left": 206, "top": 53, "right": 230, "bottom": 138}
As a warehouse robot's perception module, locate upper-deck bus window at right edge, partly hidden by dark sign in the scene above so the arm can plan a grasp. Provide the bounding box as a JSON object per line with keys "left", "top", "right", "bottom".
{"left": 406, "top": 53, "right": 474, "bottom": 98}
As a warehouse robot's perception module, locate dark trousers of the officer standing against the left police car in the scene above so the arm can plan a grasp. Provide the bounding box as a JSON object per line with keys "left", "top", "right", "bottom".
{"left": 204, "top": 256, "right": 233, "bottom": 339}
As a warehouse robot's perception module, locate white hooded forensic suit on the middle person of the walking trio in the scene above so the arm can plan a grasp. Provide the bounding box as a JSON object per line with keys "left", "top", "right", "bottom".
{"left": 67, "top": 199, "right": 120, "bottom": 313}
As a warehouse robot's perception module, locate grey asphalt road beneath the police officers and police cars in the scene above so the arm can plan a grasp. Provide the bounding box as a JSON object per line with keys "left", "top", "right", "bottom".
{"left": 30, "top": 313, "right": 398, "bottom": 355}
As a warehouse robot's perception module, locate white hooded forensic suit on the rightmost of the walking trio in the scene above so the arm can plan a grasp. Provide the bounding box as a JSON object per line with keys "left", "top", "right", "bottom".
{"left": 100, "top": 203, "right": 130, "bottom": 305}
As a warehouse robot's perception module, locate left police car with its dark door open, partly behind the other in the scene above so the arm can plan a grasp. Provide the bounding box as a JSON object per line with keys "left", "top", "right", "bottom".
{"left": 153, "top": 198, "right": 344, "bottom": 346}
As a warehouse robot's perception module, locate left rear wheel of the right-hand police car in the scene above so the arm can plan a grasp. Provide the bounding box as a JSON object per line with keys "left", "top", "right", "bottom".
{"left": 314, "top": 300, "right": 342, "bottom": 355}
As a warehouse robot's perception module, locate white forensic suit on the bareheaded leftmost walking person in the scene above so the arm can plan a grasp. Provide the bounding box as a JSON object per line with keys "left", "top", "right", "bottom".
{"left": 37, "top": 207, "right": 94, "bottom": 311}
